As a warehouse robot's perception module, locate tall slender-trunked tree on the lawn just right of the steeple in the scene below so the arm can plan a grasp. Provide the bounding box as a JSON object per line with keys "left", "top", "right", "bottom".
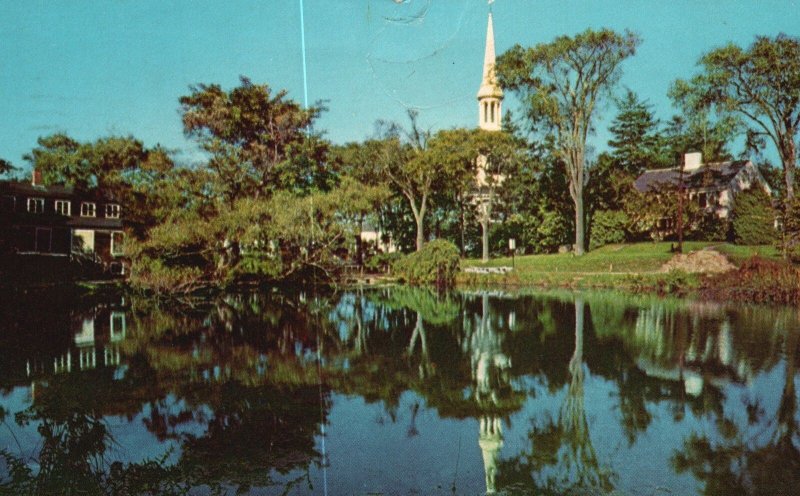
{"left": 497, "top": 29, "right": 639, "bottom": 255}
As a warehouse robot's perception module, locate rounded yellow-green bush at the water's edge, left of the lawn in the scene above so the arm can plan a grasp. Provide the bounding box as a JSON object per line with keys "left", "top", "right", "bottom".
{"left": 394, "top": 239, "right": 461, "bottom": 288}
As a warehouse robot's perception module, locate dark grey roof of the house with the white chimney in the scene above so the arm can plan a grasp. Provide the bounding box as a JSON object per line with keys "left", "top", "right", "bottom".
{"left": 634, "top": 160, "right": 750, "bottom": 193}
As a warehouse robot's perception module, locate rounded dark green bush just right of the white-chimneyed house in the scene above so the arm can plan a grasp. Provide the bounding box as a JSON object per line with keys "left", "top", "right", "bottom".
{"left": 733, "top": 188, "right": 777, "bottom": 245}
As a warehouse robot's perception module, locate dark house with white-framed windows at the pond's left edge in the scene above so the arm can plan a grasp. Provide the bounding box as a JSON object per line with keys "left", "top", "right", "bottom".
{"left": 0, "top": 171, "right": 124, "bottom": 273}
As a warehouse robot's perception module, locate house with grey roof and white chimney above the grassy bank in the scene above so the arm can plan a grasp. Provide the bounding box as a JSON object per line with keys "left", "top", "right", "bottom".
{"left": 634, "top": 153, "right": 771, "bottom": 218}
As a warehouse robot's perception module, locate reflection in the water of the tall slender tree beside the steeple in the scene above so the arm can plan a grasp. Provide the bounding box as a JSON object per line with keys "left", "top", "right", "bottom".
{"left": 500, "top": 296, "right": 613, "bottom": 494}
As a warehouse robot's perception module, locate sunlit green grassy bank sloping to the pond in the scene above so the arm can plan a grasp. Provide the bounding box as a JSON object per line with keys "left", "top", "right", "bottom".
{"left": 457, "top": 242, "right": 779, "bottom": 292}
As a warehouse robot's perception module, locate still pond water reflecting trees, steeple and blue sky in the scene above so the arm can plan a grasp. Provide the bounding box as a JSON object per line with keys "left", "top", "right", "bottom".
{"left": 0, "top": 287, "right": 800, "bottom": 495}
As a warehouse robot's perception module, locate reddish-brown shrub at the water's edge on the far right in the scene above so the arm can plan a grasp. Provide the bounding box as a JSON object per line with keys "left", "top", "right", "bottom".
{"left": 703, "top": 257, "right": 800, "bottom": 304}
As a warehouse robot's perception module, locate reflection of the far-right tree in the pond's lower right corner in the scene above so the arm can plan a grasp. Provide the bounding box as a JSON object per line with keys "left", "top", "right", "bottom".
{"left": 672, "top": 329, "right": 800, "bottom": 495}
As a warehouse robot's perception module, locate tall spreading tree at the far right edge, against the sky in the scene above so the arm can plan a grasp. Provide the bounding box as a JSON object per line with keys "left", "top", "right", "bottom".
{"left": 675, "top": 34, "right": 800, "bottom": 200}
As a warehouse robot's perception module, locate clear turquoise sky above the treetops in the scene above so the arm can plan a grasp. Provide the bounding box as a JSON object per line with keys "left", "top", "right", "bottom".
{"left": 0, "top": 0, "right": 800, "bottom": 167}
